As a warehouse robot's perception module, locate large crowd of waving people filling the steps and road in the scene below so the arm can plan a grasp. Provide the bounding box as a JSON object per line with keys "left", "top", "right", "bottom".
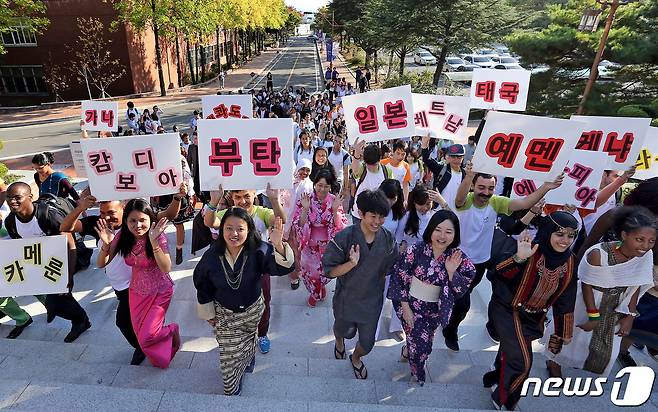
{"left": 0, "top": 73, "right": 658, "bottom": 410}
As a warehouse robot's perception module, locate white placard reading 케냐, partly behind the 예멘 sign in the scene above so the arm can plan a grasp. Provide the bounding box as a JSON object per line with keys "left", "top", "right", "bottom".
{"left": 571, "top": 115, "right": 651, "bottom": 170}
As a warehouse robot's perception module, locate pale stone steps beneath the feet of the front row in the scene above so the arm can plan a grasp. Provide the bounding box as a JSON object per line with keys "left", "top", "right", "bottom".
{"left": 0, "top": 230, "right": 658, "bottom": 412}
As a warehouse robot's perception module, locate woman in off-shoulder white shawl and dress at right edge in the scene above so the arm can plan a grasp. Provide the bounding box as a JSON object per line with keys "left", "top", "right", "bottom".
{"left": 546, "top": 207, "right": 656, "bottom": 376}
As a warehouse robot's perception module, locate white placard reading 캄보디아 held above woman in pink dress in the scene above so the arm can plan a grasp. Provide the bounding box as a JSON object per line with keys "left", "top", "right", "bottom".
{"left": 81, "top": 133, "right": 183, "bottom": 200}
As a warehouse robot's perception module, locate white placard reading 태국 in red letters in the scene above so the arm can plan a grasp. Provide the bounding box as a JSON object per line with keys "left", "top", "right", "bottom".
{"left": 471, "top": 69, "right": 530, "bottom": 112}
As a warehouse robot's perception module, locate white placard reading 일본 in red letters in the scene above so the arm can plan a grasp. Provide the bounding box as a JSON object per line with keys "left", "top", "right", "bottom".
{"left": 343, "top": 85, "right": 416, "bottom": 144}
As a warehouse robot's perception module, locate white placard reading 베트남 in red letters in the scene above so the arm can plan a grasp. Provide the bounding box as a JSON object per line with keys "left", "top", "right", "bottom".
{"left": 412, "top": 93, "right": 469, "bottom": 143}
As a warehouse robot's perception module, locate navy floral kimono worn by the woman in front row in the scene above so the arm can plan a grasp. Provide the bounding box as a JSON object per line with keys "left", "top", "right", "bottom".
{"left": 388, "top": 242, "right": 475, "bottom": 382}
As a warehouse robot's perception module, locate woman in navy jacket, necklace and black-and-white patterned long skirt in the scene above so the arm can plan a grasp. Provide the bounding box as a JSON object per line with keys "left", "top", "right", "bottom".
{"left": 194, "top": 207, "right": 294, "bottom": 395}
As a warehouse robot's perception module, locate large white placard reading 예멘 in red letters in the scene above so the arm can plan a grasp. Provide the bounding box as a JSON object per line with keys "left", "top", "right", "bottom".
{"left": 473, "top": 112, "right": 583, "bottom": 182}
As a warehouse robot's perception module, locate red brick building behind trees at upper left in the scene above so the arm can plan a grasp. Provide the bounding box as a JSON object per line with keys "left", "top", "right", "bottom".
{"left": 0, "top": 0, "right": 237, "bottom": 107}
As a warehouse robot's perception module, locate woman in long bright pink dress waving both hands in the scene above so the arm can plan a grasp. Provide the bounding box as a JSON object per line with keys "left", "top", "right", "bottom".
{"left": 96, "top": 199, "right": 181, "bottom": 369}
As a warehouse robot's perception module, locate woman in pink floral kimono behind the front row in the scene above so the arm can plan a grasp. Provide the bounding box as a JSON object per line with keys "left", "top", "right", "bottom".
{"left": 292, "top": 170, "right": 347, "bottom": 307}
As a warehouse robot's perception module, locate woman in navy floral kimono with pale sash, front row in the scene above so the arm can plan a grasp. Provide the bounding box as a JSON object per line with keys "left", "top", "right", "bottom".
{"left": 388, "top": 210, "right": 475, "bottom": 386}
